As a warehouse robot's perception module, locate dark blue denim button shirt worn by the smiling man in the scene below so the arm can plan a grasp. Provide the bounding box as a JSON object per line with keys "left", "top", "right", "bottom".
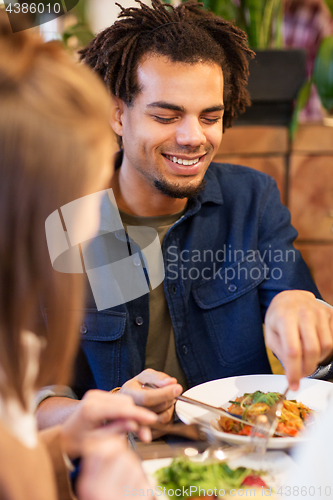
{"left": 72, "top": 163, "right": 320, "bottom": 398}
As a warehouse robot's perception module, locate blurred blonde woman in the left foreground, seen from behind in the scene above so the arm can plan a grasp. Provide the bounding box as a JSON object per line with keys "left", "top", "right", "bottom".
{"left": 0, "top": 11, "right": 156, "bottom": 500}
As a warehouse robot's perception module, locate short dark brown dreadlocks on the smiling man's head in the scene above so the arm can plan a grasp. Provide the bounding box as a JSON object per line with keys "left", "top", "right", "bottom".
{"left": 80, "top": 0, "right": 254, "bottom": 129}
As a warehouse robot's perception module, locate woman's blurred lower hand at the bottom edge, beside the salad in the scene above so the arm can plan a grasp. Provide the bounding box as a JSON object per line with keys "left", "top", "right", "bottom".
{"left": 77, "top": 437, "right": 151, "bottom": 500}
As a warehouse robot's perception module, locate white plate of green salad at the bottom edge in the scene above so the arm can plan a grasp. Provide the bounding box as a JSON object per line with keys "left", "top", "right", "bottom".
{"left": 143, "top": 451, "right": 294, "bottom": 500}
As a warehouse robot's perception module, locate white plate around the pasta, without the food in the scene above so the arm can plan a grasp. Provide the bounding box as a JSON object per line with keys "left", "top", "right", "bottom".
{"left": 176, "top": 375, "right": 333, "bottom": 449}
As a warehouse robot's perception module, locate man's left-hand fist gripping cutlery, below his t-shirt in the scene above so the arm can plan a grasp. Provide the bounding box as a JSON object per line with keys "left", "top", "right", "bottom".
{"left": 120, "top": 368, "right": 183, "bottom": 424}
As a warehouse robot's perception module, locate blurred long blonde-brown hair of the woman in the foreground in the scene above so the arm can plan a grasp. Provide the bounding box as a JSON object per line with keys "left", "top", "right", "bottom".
{"left": 0, "top": 11, "right": 113, "bottom": 404}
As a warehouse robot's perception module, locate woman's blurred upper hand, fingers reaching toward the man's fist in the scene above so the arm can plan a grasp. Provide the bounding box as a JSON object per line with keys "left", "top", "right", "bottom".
{"left": 61, "top": 390, "right": 157, "bottom": 459}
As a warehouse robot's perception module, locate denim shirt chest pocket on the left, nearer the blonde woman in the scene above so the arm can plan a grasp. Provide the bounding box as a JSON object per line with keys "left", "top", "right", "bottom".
{"left": 77, "top": 309, "right": 126, "bottom": 390}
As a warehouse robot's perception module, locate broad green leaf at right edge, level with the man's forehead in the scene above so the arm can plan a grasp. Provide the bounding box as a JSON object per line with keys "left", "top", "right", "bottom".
{"left": 313, "top": 36, "right": 333, "bottom": 111}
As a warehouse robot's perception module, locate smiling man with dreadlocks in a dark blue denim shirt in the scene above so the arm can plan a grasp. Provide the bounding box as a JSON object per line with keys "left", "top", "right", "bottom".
{"left": 38, "top": 0, "right": 333, "bottom": 426}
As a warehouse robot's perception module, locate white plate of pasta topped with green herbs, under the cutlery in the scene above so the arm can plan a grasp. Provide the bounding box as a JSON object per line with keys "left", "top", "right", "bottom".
{"left": 176, "top": 375, "right": 333, "bottom": 449}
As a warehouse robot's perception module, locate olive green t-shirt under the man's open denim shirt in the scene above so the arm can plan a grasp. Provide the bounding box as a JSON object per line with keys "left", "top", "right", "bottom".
{"left": 119, "top": 210, "right": 188, "bottom": 390}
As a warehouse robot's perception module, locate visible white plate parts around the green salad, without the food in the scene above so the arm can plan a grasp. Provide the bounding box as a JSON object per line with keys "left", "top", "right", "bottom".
{"left": 142, "top": 451, "right": 295, "bottom": 499}
